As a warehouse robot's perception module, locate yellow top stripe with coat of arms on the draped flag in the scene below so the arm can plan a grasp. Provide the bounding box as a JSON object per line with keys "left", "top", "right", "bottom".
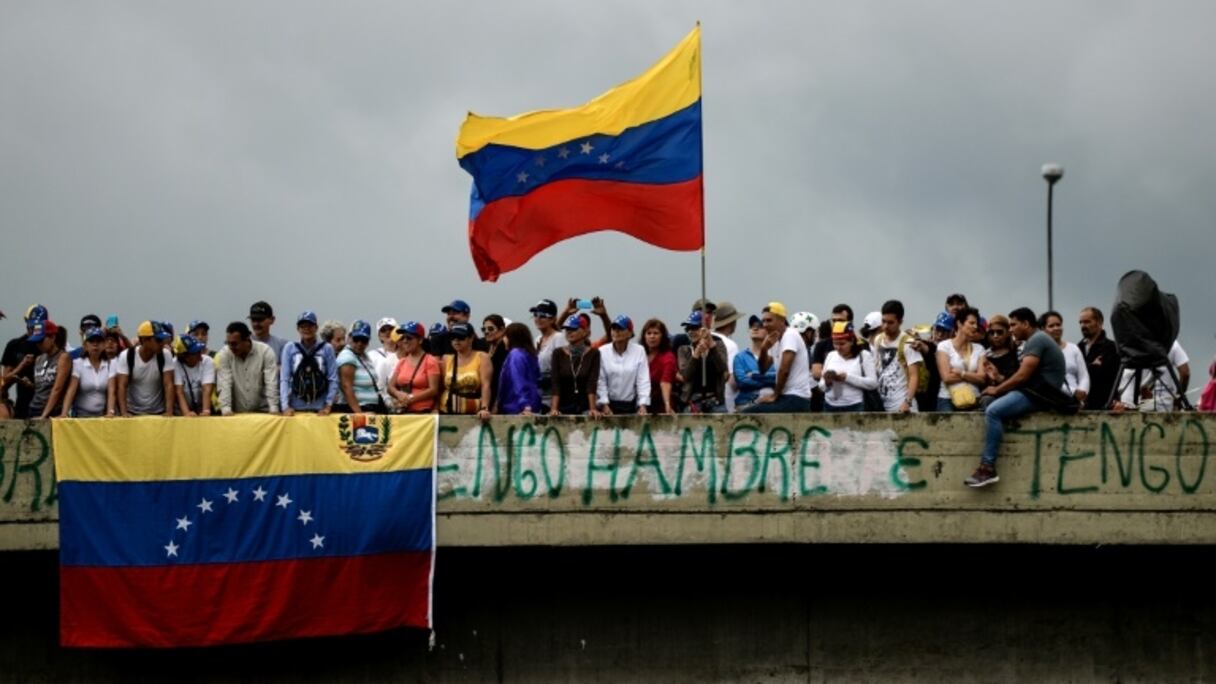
{"left": 52, "top": 414, "right": 438, "bottom": 482}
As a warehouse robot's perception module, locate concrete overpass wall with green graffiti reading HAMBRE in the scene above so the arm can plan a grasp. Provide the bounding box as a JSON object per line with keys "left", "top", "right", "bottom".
{"left": 0, "top": 414, "right": 1216, "bottom": 549}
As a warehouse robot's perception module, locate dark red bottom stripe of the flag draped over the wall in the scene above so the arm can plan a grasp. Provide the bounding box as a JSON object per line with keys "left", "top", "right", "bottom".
{"left": 60, "top": 551, "right": 430, "bottom": 647}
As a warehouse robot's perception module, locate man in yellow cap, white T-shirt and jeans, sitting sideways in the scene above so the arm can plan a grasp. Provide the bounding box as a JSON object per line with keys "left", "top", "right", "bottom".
{"left": 744, "top": 302, "right": 811, "bottom": 414}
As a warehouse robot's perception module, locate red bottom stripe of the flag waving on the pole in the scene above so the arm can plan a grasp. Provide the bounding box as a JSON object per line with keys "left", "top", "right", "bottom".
{"left": 468, "top": 175, "right": 702, "bottom": 281}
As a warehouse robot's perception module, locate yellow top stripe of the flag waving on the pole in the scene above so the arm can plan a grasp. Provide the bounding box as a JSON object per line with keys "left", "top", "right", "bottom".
{"left": 456, "top": 27, "right": 700, "bottom": 159}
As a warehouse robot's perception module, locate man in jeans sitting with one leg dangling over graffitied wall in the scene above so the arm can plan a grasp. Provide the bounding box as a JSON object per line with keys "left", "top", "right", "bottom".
{"left": 963, "top": 307, "right": 1064, "bottom": 487}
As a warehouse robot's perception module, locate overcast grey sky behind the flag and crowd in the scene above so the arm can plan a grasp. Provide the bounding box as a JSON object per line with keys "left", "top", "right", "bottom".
{"left": 0, "top": 0, "right": 1216, "bottom": 374}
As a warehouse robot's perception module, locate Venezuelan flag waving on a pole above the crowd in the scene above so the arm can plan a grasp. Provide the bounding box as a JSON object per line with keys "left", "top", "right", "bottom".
{"left": 456, "top": 27, "right": 704, "bottom": 281}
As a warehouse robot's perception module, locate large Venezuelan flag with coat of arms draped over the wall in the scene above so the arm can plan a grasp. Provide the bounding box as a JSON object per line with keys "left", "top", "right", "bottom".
{"left": 55, "top": 415, "right": 437, "bottom": 647}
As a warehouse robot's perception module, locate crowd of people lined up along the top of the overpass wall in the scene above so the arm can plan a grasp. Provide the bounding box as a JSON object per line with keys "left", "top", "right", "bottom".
{"left": 0, "top": 295, "right": 1216, "bottom": 487}
